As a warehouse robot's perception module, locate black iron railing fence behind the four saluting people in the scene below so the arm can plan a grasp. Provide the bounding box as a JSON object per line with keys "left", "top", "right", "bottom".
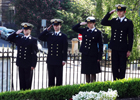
{"left": 0, "top": 45, "right": 140, "bottom": 92}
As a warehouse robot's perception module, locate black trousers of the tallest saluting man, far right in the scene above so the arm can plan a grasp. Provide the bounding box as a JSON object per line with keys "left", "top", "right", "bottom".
{"left": 111, "top": 50, "right": 127, "bottom": 80}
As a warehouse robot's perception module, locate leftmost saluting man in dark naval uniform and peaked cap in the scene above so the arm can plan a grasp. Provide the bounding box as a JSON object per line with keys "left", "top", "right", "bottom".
{"left": 8, "top": 22, "right": 38, "bottom": 90}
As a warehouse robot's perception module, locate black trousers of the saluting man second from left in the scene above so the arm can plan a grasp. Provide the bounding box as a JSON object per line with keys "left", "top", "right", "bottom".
{"left": 47, "top": 64, "right": 63, "bottom": 86}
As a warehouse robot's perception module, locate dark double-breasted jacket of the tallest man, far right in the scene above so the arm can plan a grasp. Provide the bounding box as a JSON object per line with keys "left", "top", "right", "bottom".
{"left": 101, "top": 13, "right": 134, "bottom": 51}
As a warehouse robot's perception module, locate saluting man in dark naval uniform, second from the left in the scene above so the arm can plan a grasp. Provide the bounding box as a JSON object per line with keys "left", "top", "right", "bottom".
{"left": 38, "top": 19, "right": 68, "bottom": 86}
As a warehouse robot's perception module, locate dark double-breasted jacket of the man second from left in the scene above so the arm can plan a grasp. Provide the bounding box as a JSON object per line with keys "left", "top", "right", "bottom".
{"left": 38, "top": 30, "right": 68, "bottom": 65}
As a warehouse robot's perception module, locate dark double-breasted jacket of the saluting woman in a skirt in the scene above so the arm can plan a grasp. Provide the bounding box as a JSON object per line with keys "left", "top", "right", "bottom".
{"left": 72, "top": 23, "right": 103, "bottom": 60}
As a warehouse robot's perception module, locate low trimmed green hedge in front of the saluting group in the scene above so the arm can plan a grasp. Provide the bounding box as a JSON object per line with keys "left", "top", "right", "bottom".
{"left": 0, "top": 78, "right": 140, "bottom": 100}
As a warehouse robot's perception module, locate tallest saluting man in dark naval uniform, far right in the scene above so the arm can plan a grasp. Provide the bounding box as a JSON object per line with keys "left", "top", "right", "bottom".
{"left": 101, "top": 4, "right": 134, "bottom": 80}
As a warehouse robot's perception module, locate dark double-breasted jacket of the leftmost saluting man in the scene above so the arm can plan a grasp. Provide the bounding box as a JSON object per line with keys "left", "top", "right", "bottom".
{"left": 8, "top": 32, "right": 38, "bottom": 67}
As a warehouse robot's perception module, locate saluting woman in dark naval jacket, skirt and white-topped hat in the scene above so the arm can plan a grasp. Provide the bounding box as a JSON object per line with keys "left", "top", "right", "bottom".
{"left": 72, "top": 16, "right": 103, "bottom": 83}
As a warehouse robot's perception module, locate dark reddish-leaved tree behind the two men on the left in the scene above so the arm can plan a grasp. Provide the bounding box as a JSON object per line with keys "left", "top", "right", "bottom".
{"left": 14, "top": 0, "right": 61, "bottom": 34}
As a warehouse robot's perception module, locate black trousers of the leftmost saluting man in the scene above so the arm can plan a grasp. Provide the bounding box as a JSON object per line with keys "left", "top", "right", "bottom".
{"left": 19, "top": 67, "right": 33, "bottom": 90}
